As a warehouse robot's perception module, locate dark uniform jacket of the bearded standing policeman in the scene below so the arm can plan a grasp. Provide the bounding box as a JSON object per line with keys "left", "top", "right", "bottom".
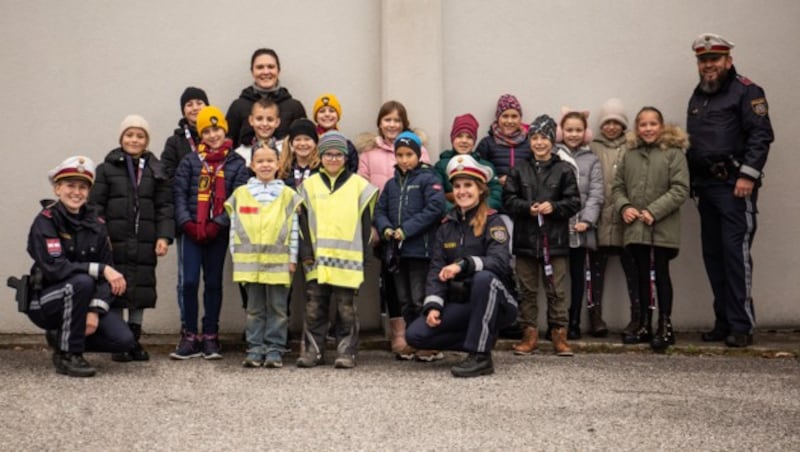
{"left": 686, "top": 66, "right": 774, "bottom": 186}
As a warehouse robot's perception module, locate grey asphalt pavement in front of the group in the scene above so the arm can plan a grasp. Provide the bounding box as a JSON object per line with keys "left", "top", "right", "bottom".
{"left": 0, "top": 337, "right": 800, "bottom": 451}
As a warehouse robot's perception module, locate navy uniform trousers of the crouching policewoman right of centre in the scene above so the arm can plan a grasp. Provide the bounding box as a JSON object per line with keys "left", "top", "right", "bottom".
{"left": 406, "top": 271, "right": 517, "bottom": 353}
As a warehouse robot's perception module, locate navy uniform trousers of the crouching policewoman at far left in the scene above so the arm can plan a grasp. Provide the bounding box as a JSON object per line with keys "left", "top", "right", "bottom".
{"left": 28, "top": 273, "right": 136, "bottom": 353}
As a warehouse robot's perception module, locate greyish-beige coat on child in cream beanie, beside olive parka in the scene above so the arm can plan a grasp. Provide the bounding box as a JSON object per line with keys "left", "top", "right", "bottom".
{"left": 589, "top": 135, "right": 626, "bottom": 247}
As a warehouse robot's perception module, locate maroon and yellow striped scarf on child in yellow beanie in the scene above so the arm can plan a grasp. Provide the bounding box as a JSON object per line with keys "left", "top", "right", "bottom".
{"left": 197, "top": 139, "right": 233, "bottom": 226}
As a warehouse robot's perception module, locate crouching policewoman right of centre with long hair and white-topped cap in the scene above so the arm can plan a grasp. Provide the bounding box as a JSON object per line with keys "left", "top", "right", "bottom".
{"left": 406, "top": 155, "right": 517, "bottom": 377}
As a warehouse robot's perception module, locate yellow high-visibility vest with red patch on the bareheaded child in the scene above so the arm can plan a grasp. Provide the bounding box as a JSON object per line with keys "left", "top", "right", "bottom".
{"left": 225, "top": 185, "right": 302, "bottom": 286}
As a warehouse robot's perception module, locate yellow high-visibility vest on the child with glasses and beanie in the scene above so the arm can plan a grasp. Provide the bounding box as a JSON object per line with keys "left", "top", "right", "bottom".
{"left": 300, "top": 174, "right": 378, "bottom": 289}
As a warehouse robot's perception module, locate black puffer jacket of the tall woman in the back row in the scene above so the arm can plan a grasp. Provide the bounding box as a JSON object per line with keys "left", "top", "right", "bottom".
{"left": 225, "top": 86, "right": 306, "bottom": 149}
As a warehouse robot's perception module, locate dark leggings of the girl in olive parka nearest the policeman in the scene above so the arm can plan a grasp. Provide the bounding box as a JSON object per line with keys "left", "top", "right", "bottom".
{"left": 626, "top": 245, "right": 678, "bottom": 317}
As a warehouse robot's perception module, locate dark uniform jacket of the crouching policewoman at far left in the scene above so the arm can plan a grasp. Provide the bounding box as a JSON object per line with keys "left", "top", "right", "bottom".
{"left": 28, "top": 200, "right": 112, "bottom": 313}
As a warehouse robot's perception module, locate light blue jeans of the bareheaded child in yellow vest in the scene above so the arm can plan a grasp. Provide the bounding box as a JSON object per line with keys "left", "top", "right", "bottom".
{"left": 245, "top": 283, "right": 289, "bottom": 355}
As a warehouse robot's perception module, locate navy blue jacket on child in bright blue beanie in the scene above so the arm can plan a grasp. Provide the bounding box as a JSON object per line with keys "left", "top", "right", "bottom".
{"left": 375, "top": 163, "right": 445, "bottom": 259}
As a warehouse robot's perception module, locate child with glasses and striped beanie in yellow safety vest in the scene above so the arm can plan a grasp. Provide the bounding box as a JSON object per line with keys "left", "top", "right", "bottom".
{"left": 297, "top": 131, "right": 378, "bottom": 369}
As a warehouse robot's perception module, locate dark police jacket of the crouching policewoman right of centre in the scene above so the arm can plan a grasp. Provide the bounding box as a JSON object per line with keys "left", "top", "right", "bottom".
{"left": 422, "top": 207, "right": 515, "bottom": 314}
